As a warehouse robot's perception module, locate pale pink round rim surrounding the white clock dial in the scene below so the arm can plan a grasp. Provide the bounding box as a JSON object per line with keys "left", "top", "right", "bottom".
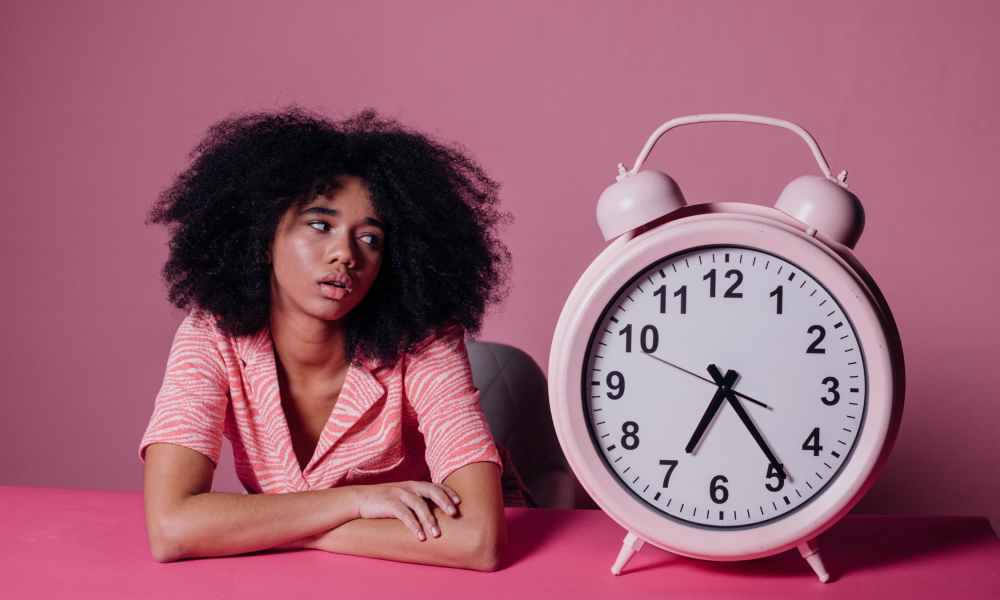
{"left": 549, "top": 207, "right": 902, "bottom": 560}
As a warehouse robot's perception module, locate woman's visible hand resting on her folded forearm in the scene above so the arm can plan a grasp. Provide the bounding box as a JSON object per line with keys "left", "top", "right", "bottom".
{"left": 353, "top": 481, "right": 461, "bottom": 541}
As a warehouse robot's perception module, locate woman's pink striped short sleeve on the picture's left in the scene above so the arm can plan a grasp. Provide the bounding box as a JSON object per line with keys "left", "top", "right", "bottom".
{"left": 139, "top": 313, "right": 229, "bottom": 472}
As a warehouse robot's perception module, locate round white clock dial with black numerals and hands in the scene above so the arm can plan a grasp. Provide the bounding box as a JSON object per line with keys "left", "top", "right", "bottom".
{"left": 582, "top": 246, "right": 867, "bottom": 528}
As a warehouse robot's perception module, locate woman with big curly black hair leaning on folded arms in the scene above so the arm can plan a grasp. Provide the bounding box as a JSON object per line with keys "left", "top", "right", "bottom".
{"left": 139, "top": 107, "right": 516, "bottom": 570}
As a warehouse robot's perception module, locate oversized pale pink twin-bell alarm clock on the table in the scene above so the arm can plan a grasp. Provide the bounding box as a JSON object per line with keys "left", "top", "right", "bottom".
{"left": 548, "top": 114, "right": 904, "bottom": 582}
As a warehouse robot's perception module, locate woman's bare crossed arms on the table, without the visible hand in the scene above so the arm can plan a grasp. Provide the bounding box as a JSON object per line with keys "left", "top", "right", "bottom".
{"left": 144, "top": 443, "right": 507, "bottom": 570}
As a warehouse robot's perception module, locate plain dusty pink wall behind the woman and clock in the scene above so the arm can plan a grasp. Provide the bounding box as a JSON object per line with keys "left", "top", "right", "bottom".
{"left": 0, "top": 1, "right": 1000, "bottom": 523}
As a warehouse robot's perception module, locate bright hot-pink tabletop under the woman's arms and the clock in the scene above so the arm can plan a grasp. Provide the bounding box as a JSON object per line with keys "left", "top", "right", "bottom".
{"left": 0, "top": 487, "right": 1000, "bottom": 600}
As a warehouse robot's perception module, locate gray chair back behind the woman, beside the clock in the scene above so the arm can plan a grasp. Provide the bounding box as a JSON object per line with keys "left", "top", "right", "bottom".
{"left": 466, "top": 339, "right": 592, "bottom": 508}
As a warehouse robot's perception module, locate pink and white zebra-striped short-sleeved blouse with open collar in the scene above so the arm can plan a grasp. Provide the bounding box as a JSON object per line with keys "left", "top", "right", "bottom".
{"left": 139, "top": 311, "right": 504, "bottom": 493}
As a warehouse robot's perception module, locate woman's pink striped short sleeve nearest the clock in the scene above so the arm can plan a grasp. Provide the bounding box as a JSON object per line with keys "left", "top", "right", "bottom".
{"left": 403, "top": 326, "right": 503, "bottom": 483}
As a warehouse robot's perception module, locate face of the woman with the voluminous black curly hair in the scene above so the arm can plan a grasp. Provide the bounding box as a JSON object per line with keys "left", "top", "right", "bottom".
{"left": 271, "top": 177, "right": 385, "bottom": 321}
